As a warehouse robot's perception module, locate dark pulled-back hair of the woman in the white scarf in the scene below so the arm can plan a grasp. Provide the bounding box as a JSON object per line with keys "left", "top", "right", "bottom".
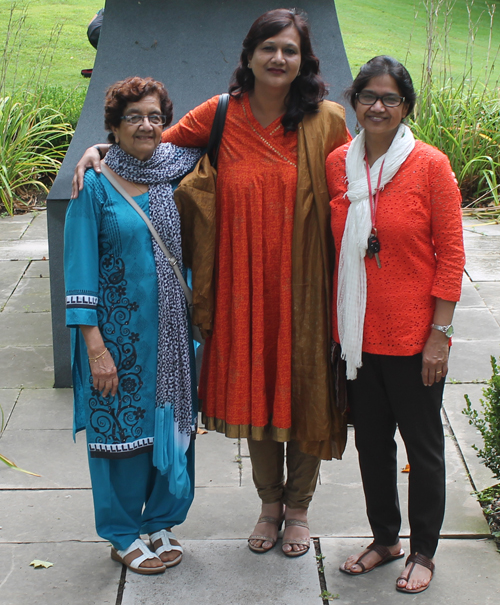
{"left": 344, "top": 55, "right": 417, "bottom": 115}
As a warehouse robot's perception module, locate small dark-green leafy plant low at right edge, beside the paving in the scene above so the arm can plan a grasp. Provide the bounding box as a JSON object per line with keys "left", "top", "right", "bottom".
{"left": 462, "top": 356, "right": 500, "bottom": 479}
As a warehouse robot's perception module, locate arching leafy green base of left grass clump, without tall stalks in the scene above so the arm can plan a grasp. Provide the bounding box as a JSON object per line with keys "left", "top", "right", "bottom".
{"left": 0, "top": 97, "right": 73, "bottom": 215}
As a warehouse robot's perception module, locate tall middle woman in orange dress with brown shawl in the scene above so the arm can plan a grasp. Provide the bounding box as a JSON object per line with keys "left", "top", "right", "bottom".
{"left": 72, "top": 9, "right": 349, "bottom": 556}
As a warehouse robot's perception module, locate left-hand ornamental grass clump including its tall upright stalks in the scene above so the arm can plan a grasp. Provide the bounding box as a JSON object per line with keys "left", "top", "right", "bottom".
{"left": 0, "top": 2, "right": 77, "bottom": 215}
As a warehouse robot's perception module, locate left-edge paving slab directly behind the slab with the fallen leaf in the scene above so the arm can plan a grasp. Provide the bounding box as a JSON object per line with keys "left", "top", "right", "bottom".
{"left": 0, "top": 488, "right": 96, "bottom": 544}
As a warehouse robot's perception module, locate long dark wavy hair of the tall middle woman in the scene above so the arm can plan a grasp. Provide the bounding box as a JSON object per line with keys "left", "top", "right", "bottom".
{"left": 229, "top": 8, "right": 328, "bottom": 132}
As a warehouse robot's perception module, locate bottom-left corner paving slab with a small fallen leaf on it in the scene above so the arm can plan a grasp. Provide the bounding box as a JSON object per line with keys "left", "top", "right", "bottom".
{"left": 0, "top": 542, "right": 122, "bottom": 605}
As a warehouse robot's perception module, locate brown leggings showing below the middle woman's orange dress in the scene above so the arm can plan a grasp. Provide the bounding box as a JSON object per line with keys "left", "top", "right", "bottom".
{"left": 248, "top": 437, "right": 321, "bottom": 508}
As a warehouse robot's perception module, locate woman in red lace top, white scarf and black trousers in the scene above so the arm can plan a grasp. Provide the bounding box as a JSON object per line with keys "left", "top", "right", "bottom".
{"left": 326, "top": 56, "right": 464, "bottom": 593}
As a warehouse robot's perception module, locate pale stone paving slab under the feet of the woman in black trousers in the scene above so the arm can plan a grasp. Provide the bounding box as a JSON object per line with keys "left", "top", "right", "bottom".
{"left": 320, "top": 538, "right": 500, "bottom": 605}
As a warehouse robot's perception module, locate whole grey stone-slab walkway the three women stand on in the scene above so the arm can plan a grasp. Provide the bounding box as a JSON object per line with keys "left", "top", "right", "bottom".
{"left": 0, "top": 213, "right": 500, "bottom": 605}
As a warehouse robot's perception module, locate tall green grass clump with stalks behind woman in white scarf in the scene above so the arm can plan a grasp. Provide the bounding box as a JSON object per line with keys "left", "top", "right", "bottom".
{"left": 410, "top": 0, "right": 500, "bottom": 221}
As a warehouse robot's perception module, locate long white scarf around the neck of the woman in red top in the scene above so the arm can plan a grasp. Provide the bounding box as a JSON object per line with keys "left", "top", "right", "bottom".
{"left": 337, "top": 124, "right": 415, "bottom": 380}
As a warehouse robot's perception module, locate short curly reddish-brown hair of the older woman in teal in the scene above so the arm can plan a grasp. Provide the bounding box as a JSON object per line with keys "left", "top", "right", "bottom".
{"left": 104, "top": 76, "right": 174, "bottom": 143}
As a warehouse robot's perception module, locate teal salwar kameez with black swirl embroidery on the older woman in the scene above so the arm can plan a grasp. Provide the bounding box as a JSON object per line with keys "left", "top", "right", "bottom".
{"left": 64, "top": 158, "right": 197, "bottom": 550}
